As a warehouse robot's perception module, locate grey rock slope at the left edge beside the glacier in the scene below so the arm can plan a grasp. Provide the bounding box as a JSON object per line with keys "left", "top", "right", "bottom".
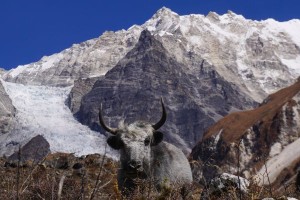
{"left": 0, "top": 81, "right": 16, "bottom": 134}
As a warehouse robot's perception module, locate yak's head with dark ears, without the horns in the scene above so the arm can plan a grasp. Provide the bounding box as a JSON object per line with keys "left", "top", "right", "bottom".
{"left": 107, "top": 122, "right": 163, "bottom": 175}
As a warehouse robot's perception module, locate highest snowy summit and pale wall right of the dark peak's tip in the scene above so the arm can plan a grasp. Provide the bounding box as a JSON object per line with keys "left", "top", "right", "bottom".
{"left": 142, "top": 8, "right": 300, "bottom": 101}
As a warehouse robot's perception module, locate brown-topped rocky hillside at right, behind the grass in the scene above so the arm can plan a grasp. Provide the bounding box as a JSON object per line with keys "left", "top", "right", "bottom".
{"left": 191, "top": 81, "right": 300, "bottom": 189}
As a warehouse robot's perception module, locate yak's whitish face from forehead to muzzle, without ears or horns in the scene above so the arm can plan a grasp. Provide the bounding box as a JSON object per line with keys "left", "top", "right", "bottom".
{"left": 119, "top": 123, "right": 153, "bottom": 172}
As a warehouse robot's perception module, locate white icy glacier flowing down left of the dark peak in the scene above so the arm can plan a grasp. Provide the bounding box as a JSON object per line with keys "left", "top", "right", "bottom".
{"left": 0, "top": 81, "right": 117, "bottom": 158}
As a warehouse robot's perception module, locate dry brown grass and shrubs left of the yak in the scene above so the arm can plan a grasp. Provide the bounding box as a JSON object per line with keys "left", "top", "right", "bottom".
{"left": 0, "top": 155, "right": 118, "bottom": 200}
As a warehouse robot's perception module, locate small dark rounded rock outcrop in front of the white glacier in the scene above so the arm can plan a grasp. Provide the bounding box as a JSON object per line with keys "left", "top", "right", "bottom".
{"left": 8, "top": 135, "right": 50, "bottom": 163}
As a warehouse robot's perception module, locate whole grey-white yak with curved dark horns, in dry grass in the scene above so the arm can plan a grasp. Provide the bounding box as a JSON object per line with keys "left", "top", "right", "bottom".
{"left": 99, "top": 99, "right": 193, "bottom": 191}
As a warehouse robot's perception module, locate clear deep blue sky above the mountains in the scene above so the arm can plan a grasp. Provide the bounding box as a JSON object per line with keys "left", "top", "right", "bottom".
{"left": 0, "top": 0, "right": 300, "bottom": 69}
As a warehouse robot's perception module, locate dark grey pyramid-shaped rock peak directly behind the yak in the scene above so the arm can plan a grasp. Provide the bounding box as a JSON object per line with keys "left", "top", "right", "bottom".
{"left": 78, "top": 31, "right": 254, "bottom": 151}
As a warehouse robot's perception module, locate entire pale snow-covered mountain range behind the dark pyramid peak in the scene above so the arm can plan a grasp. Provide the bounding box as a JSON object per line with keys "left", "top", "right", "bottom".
{"left": 3, "top": 8, "right": 300, "bottom": 101}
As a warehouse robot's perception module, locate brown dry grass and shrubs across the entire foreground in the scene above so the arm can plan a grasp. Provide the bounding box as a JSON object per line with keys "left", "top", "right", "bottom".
{"left": 0, "top": 155, "right": 299, "bottom": 200}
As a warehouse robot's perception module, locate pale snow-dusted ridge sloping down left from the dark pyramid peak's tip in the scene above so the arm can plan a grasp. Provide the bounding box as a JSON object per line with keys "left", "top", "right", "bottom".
{"left": 3, "top": 27, "right": 139, "bottom": 87}
